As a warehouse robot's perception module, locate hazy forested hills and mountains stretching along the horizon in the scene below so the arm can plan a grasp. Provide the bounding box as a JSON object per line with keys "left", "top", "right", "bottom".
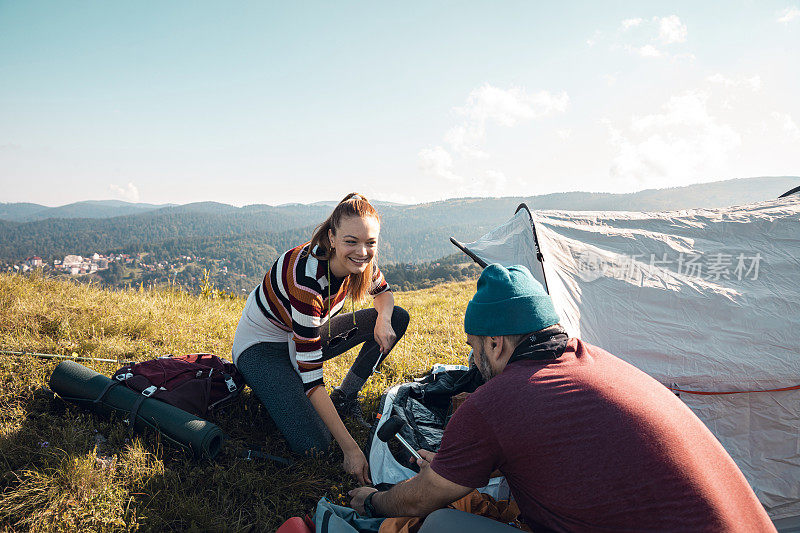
{"left": 0, "top": 176, "right": 800, "bottom": 262}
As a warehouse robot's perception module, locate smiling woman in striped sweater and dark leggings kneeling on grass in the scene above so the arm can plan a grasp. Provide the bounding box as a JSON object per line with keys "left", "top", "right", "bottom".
{"left": 233, "top": 193, "right": 408, "bottom": 483}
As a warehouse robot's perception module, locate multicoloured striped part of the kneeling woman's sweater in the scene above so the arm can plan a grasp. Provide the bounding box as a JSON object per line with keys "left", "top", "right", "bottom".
{"left": 255, "top": 243, "right": 390, "bottom": 394}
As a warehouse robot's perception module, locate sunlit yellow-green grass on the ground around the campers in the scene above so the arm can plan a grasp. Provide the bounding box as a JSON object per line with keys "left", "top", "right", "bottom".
{"left": 0, "top": 275, "right": 474, "bottom": 531}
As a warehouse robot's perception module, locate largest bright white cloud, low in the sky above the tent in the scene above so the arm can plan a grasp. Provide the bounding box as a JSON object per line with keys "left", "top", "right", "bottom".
{"left": 609, "top": 90, "right": 742, "bottom": 187}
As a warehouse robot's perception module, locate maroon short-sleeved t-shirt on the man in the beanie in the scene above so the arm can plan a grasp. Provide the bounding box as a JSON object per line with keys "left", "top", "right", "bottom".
{"left": 431, "top": 339, "right": 775, "bottom": 532}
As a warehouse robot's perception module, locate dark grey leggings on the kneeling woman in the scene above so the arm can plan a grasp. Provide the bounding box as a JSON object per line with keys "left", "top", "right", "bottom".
{"left": 231, "top": 306, "right": 409, "bottom": 453}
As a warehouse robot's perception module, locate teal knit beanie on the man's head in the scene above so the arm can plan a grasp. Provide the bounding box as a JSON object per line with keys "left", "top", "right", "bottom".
{"left": 464, "top": 263, "right": 559, "bottom": 337}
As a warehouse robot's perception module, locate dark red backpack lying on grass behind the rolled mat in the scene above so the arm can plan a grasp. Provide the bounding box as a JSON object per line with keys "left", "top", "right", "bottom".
{"left": 111, "top": 353, "right": 244, "bottom": 417}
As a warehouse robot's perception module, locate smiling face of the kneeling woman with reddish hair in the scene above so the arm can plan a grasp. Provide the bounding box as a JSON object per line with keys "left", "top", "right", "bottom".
{"left": 328, "top": 217, "right": 381, "bottom": 278}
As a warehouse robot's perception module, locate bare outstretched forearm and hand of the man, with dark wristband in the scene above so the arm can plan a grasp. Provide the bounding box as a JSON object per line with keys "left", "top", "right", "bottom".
{"left": 349, "top": 454, "right": 473, "bottom": 516}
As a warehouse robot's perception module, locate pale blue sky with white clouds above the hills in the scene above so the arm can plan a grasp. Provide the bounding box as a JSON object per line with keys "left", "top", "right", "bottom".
{"left": 0, "top": 0, "right": 800, "bottom": 206}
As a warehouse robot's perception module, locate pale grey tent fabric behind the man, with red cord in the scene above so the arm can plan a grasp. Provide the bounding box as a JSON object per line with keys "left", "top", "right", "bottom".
{"left": 456, "top": 195, "right": 800, "bottom": 519}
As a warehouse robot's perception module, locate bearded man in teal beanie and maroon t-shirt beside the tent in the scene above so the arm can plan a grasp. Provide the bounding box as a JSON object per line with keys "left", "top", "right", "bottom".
{"left": 350, "top": 264, "right": 775, "bottom": 533}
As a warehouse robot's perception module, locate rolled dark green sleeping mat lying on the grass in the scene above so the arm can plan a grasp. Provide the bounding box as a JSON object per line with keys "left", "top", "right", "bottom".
{"left": 50, "top": 361, "right": 224, "bottom": 459}
